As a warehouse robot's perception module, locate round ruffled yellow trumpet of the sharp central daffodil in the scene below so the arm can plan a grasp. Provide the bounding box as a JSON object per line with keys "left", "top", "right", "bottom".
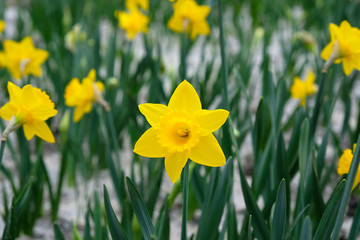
{"left": 155, "top": 110, "right": 200, "bottom": 153}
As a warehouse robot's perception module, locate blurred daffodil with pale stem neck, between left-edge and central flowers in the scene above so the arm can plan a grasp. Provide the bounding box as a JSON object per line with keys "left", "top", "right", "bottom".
{"left": 64, "top": 69, "right": 110, "bottom": 122}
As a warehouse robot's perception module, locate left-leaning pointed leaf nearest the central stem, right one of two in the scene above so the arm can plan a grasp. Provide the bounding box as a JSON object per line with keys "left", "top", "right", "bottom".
{"left": 126, "top": 177, "right": 156, "bottom": 240}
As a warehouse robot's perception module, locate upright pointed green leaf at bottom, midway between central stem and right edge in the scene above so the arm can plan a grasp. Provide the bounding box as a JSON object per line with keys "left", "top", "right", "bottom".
{"left": 270, "top": 179, "right": 286, "bottom": 240}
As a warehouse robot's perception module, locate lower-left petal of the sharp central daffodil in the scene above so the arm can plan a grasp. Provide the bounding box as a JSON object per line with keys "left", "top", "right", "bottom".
{"left": 134, "top": 127, "right": 166, "bottom": 158}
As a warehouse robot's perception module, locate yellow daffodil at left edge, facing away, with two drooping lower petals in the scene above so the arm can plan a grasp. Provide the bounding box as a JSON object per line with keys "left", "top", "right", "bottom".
{"left": 0, "top": 82, "right": 57, "bottom": 143}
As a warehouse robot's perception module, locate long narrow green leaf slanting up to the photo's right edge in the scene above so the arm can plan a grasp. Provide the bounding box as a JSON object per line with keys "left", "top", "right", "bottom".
{"left": 331, "top": 136, "right": 360, "bottom": 240}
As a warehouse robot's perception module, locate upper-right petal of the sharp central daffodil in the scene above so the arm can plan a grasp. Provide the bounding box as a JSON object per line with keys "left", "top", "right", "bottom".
{"left": 194, "top": 109, "right": 229, "bottom": 132}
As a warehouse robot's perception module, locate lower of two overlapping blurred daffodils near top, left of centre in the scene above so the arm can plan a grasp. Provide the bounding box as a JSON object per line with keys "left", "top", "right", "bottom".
{"left": 115, "top": 8, "right": 149, "bottom": 40}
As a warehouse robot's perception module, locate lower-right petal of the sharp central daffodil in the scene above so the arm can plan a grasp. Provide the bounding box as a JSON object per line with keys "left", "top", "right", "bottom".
{"left": 189, "top": 134, "right": 226, "bottom": 167}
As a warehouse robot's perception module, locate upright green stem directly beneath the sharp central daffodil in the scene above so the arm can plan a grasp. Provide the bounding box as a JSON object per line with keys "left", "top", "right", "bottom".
{"left": 181, "top": 161, "right": 189, "bottom": 240}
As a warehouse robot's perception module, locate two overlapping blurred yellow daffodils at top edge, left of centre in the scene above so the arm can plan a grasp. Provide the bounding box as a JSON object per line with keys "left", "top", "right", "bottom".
{"left": 114, "top": 0, "right": 149, "bottom": 40}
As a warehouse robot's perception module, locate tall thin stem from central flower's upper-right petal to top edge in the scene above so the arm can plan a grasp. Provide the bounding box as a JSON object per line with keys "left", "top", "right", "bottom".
{"left": 219, "top": 0, "right": 229, "bottom": 109}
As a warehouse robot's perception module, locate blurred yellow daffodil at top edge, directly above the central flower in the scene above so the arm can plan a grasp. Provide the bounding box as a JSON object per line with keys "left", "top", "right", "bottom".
{"left": 167, "top": 0, "right": 211, "bottom": 40}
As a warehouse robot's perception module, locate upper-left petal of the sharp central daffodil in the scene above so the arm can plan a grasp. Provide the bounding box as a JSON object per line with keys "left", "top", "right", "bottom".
{"left": 139, "top": 103, "right": 169, "bottom": 126}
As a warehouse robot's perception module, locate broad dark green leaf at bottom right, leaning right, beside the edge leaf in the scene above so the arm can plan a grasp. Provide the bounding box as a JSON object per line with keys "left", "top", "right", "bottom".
{"left": 314, "top": 180, "right": 346, "bottom": 240}
